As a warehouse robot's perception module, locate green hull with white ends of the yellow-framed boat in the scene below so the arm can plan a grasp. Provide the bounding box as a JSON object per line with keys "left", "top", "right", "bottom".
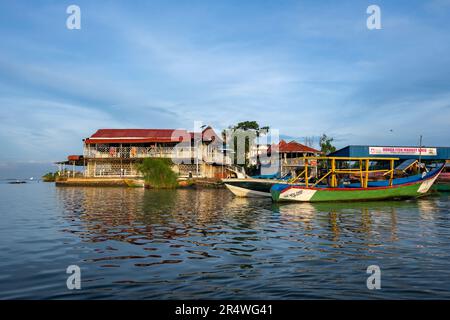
{"left": 271, "top": 165, "right": 440, "bottom": 202}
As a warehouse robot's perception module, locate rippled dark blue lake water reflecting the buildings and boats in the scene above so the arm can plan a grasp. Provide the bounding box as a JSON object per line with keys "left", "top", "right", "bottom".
{"left": 0, "top": 183, "right": 450, "bottom": 299}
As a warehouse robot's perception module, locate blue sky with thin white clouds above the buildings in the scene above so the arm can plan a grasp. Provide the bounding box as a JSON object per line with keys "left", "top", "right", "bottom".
{"left": 0, "top": 0, "right": 450, "bottom": 176}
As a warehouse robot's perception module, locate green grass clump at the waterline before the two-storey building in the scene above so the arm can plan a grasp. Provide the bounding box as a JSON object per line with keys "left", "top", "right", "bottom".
{"left": 137, "top": 158, "right": 178, "bottom": 189}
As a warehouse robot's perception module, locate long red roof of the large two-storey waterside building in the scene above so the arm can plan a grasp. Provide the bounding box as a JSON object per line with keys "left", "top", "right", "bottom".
{"left": 85, "top": 129, "right": 190, "bottom": 144}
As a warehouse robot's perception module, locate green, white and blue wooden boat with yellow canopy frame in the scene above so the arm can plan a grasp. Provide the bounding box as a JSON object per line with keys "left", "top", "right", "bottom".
{"left": 271, "top": 157, "right": 444, "bottom": 202}
